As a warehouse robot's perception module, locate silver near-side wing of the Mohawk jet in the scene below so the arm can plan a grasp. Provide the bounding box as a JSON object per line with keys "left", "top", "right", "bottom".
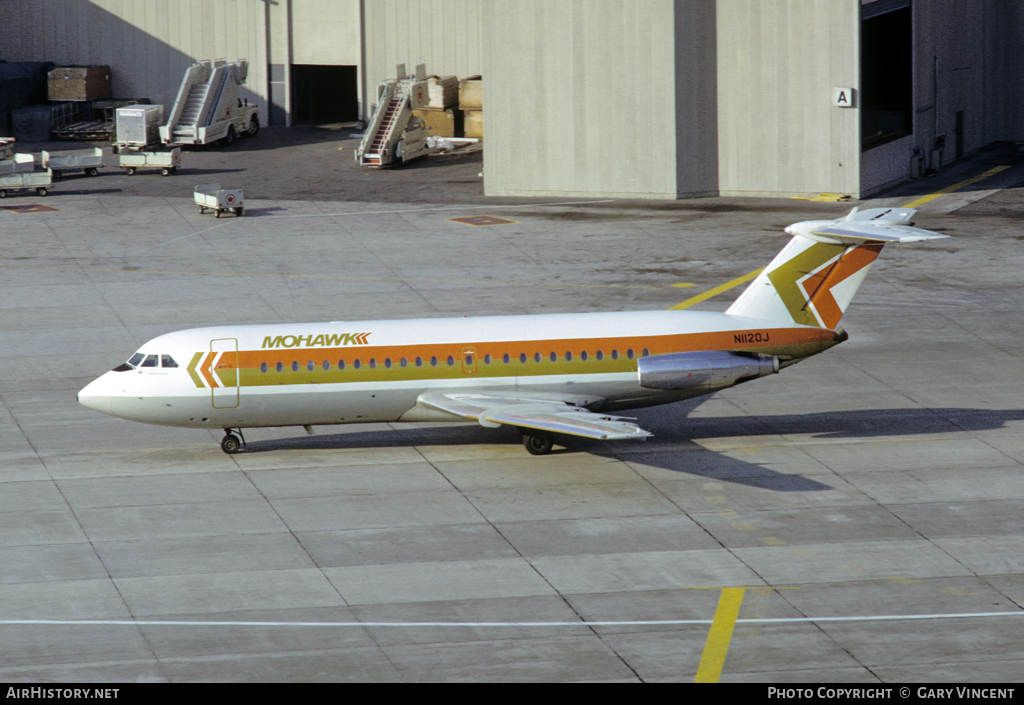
{"left": 418, "top": 391, "right": 652, "bottom": 441}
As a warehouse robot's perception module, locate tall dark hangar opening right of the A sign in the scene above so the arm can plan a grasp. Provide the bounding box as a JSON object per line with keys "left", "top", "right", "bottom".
{"left": 860, "top": 0, "right": 913, "bottom": 150}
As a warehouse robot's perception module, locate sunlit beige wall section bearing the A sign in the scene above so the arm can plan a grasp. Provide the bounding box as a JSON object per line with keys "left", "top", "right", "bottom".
{"left": 718, "top": 0, "right": 860, "bottom": 196}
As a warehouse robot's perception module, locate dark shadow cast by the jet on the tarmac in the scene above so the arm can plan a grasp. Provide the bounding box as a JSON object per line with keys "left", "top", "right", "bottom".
{"left": 237, "top": 400, "right": 1024, "bottom": 492}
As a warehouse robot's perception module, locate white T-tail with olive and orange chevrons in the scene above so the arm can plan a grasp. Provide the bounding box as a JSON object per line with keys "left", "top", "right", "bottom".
{"left": 726, "top": 208, "right": 949, "bottom": 330}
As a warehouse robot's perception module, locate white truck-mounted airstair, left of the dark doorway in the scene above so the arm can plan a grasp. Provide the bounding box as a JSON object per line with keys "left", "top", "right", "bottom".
{"left": 160, "top": 58, "right": 259, "bottom": 144}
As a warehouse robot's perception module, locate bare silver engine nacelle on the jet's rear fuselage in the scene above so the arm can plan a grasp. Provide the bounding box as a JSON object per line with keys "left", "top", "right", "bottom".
{"left": 637, "top": 350, "right": 778, "bottom": 393}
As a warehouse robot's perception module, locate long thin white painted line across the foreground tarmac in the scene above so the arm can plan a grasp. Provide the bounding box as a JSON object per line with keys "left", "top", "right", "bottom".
{"left": 0, "top": 610, "right": 1024, "bottom": 628}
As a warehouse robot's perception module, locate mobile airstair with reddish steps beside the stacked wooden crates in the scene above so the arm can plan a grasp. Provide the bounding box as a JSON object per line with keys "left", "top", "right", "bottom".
{"left": 355, "top": 64, "right": 429, "bottom": 169}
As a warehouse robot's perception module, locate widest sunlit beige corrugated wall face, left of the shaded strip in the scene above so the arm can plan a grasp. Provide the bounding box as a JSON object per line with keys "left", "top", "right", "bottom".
{"left": 483, "top": 0, "right": 677, "bottom": 198}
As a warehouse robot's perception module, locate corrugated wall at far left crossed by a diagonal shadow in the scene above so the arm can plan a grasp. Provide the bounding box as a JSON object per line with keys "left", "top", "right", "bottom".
{"left": 0, "top": 0, "right": 267, "bottom": 124}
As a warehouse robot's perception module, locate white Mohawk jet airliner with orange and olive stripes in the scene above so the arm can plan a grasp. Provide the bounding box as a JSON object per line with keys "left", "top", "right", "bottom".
{"left": 78, "top": 208, "right": 947, "bottom": 455}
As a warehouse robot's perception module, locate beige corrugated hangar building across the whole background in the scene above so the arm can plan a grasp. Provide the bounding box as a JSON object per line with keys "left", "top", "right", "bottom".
{"left": 0, "top": 0, "right": 1024, "bottom": 199}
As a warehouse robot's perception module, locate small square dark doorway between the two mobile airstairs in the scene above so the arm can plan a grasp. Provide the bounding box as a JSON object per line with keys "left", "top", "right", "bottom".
{"left": 292, "top": 64, "right": 359, "bottom": 125}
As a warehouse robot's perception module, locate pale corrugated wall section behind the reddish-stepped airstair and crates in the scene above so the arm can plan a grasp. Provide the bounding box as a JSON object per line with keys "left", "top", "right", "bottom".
{"left": 362, "top": 0, "right": 489, "bottom": 112}
